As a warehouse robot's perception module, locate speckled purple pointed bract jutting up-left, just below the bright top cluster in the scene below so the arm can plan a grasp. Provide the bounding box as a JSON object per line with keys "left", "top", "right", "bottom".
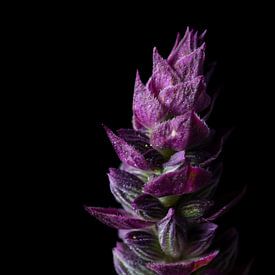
{"left": 104, "top": 126, "right": 149, "bottom": 170}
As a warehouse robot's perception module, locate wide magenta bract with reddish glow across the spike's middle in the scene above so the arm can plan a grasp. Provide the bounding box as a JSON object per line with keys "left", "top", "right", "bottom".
{"left": 144, "top": 166, "right": 211, "bottom": 197}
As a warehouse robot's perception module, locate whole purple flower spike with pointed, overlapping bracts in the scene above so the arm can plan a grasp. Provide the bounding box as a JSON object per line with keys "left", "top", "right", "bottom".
{"left": 86, "top": 28, "right": 248, "bottom": 275}
